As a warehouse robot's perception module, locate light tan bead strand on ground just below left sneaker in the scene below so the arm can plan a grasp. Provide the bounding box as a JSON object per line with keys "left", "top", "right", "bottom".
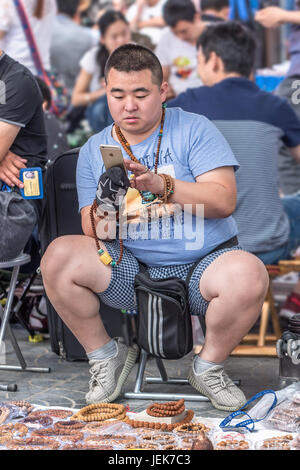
{"left": 71, "top": 403, "right": 126, "bottom": 422}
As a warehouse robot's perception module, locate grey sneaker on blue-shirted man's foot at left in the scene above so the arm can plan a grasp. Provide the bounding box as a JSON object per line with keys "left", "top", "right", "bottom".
{"left": 85, "top": 338, "right": 138, "bottom": 404}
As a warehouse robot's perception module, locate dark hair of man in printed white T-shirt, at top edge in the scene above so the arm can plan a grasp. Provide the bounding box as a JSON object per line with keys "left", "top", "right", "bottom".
{"left": 163, "top": 0, "right": 196, "bottom": 28}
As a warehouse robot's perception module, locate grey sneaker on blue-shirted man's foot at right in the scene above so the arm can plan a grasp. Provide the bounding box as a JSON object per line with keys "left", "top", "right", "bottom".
{"left": 188, "top": 364, "right": 247, "bottom": 411}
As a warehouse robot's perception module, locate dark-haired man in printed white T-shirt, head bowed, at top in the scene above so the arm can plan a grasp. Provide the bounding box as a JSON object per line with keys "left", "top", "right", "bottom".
{"left": 156, "top": 0, "right": 204, "bottom": 99}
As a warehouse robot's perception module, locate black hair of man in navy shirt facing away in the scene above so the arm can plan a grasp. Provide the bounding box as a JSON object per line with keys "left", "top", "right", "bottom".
{"left": 197, "top": 21, "right": 256, "bottom": 77}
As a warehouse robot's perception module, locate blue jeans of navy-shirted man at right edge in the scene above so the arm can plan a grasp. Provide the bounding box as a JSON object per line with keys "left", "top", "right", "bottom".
{"left": 254, "top": 191, "right": 300, "bottom": 264}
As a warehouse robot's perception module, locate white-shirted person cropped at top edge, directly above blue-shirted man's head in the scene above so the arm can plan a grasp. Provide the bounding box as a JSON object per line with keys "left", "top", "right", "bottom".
{"left": 126, "top": 0, "right": 166, "bottom": 46}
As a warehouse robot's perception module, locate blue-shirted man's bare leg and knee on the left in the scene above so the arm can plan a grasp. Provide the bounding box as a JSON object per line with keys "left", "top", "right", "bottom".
{"left": 41, "top": 235, "right": 111, "bottom": 353}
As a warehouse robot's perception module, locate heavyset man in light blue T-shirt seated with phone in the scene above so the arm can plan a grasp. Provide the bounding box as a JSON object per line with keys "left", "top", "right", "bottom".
{"left": 41, "top": 44, "right": 268, "bottom": 410}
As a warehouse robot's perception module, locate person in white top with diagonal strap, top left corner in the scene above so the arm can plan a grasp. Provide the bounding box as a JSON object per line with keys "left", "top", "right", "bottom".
{"left": 0, "top": 0, "right": 57, "bottom": 75}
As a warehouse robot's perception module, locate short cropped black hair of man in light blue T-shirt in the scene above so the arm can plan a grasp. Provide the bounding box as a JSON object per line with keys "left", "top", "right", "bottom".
{"left": 104, "top": 43, "right": 163, "bottom": 87}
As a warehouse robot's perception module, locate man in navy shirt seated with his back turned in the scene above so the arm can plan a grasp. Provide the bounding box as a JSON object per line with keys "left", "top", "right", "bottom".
{"left": 169, "top": 22, "right": 300, "bottom": 316}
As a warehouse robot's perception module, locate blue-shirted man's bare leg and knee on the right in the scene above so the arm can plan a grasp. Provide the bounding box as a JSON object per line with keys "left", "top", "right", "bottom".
{"left": 199, "top": 251, "right": 269, "bottom": 362}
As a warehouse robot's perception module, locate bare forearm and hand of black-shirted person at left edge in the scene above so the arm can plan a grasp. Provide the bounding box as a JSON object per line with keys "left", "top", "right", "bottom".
{"left": 0, "top": 121, "right": 26, "bottom": 188}
